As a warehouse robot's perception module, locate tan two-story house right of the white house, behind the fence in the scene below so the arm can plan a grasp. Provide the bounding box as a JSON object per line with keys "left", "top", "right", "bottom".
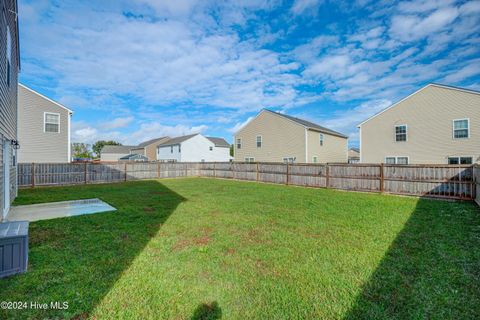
{"left": 234, "top": 109, "right": 348, "bottom": 163}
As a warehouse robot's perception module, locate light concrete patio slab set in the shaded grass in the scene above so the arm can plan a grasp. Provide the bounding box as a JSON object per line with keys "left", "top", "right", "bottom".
{"left": 7, "top": 198, "right": 117, "bottom": 221}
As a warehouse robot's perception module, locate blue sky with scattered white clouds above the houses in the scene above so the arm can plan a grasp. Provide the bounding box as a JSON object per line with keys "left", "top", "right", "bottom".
{"left": 19, "top": 0, "right": 480, "bottom": 145}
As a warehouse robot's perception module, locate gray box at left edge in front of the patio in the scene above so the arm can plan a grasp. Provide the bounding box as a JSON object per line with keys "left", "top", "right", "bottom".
{"left": 0, "top": 221, "right": 28, "bottom": 278}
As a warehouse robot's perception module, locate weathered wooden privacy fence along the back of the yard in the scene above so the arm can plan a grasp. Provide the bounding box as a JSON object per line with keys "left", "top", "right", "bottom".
{"left": 18, "top": 162, "right": 474, "bottom": 200}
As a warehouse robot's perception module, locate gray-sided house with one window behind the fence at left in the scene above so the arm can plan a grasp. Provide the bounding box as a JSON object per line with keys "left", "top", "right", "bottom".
{"left": 18, "top": 84, "right": 73, "bottom": 163}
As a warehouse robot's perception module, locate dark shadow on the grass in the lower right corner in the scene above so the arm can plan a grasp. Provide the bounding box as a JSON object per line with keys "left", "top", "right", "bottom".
{"left": 345, "top": 199, "right": 480, "bottom": 320}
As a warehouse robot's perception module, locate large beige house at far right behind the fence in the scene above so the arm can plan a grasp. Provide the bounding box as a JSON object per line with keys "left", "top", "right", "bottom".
{"left": 359, "top": 84, "right": 480, "bottom": 164}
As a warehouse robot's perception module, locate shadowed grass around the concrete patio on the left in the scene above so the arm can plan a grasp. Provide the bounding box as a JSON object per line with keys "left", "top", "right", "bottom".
{"left": 0, "top": 180, "right": 186, "bottom": 319}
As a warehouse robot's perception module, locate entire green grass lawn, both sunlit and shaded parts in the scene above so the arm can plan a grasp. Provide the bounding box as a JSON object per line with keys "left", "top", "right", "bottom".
{"left": 0, "top": 178, "right": 480, "bottom": 319}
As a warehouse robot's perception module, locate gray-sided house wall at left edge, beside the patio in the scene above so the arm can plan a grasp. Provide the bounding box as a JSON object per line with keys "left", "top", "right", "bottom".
{"left": 0, "top": 0, "right": 20, "bottom": 220}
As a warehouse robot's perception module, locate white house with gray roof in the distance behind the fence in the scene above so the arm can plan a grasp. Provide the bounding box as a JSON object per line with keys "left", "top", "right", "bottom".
{"left": 157, "top": 134, "right": 231, "bottom": 162}
